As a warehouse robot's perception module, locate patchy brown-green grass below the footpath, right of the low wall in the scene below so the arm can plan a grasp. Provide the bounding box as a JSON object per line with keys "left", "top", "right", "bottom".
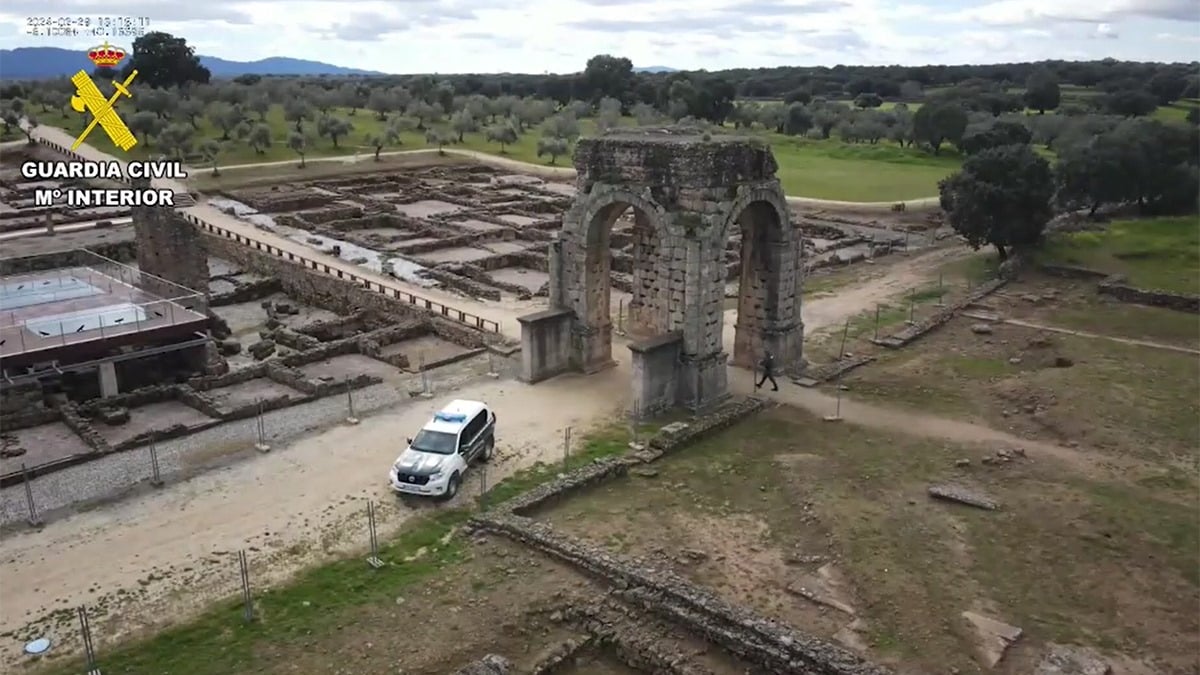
{"left": 539, "top": 401, "right": 1200, "bottom": 673}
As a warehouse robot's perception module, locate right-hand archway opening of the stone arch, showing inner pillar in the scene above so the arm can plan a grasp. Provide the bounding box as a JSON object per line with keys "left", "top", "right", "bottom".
{"left": 733, "top": 201, "right": 797, "bottom": 368}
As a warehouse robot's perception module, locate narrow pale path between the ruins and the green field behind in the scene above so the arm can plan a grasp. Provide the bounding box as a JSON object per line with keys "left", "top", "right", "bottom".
{"left": 34, "top": 126, "right": 937, "bottom": 211}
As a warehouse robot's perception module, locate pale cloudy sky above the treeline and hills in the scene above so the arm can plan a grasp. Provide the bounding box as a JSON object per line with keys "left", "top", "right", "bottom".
{"left": 0, "top": 0, "right": 1200, "bottom": 73}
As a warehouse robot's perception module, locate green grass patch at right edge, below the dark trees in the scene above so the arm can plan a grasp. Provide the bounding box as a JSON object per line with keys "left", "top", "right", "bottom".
{"left": 1040, "top": 216, "right": 1200, "bottom": 293}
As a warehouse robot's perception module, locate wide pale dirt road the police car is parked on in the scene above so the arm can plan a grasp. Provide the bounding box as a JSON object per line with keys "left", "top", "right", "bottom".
{"left": 0, "top": 369, "right": 629, "bottom": 670}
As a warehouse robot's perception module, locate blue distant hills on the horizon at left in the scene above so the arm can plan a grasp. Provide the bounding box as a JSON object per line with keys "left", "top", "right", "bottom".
{"left": 0, "top": 47, "right": 384, "bottom": 79}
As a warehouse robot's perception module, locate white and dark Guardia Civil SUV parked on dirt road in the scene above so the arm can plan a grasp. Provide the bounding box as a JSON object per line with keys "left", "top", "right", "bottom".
{"left": 389, "top": 400, "right": 496, "bottom": 500}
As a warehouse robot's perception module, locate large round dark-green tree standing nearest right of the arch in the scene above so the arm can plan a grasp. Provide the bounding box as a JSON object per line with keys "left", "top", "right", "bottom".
{"left": 936, "top": 142, "right": 1055, "bottom": 261}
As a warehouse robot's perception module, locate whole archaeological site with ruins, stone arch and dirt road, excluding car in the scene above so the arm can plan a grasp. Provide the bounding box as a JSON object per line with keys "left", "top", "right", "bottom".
{"left": 0, "top": 129, "right": 1198, "bottom": 675}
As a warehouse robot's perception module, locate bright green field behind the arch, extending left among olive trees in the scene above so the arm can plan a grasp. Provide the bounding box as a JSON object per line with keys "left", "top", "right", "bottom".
{"left": 18, "top": 99, "right": 959, "bottom": 202}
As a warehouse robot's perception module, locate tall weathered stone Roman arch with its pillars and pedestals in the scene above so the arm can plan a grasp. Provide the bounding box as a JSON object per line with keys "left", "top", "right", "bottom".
{"left": 522, "top": 129, "right": 804, "bottom": 413}
